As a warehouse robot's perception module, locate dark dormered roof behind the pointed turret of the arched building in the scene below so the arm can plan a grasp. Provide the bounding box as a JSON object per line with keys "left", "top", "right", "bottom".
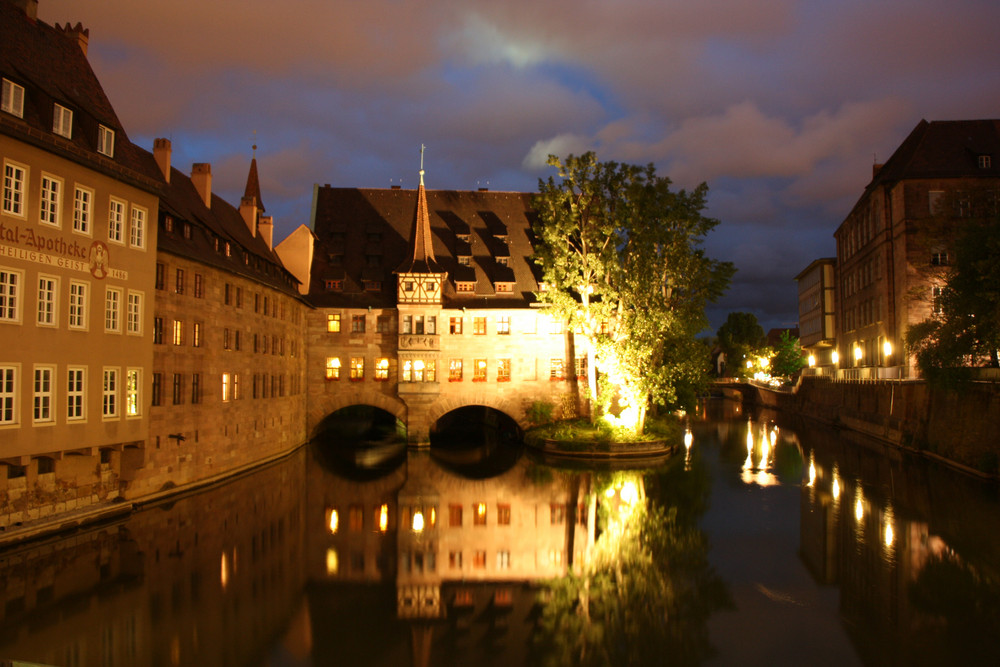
{"left": 309, "top": 186, "right": 538, "bottom": 308}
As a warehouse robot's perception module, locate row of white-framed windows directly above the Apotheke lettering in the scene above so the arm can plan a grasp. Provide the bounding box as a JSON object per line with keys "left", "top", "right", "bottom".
{"left": 0, "top": 160, "right": 148, "bottom": 250}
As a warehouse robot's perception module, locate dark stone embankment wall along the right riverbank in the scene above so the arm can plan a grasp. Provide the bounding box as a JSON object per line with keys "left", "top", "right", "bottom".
{"left": 728, "top": 377, "right": 1000, "bottom": 478}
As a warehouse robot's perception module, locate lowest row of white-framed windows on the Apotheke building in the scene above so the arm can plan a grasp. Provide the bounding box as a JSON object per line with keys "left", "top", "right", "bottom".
{"left": 0, "top": 364, "right": 142, "bottom": 426}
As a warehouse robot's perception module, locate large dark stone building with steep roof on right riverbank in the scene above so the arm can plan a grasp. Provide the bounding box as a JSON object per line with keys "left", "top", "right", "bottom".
{"left": 834, "top": 120, "right": 1000, "bottom": 378}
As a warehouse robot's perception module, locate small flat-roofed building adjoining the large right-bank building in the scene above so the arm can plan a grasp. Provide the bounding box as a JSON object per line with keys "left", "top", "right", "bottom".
{"left": 795, "top": 257, "right": 837, "bottom": 374}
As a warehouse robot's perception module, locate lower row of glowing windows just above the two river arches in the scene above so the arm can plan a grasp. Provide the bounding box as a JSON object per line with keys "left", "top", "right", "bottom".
{"left": 325, "top": 357, "right": 587, "bottom": 382}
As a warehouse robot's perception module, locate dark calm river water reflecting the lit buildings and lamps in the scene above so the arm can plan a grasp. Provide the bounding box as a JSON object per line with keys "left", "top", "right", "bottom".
{"left": 0, "top": 401, "right": 1000, "bottom": 666}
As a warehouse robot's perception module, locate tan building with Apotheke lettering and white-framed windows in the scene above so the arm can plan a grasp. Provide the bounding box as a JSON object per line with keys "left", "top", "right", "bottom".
{"left": 0, "top": 0, "right": 162, "bottom": 529}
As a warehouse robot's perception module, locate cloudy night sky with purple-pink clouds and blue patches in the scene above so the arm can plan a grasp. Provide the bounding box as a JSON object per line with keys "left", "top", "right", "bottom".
{"left": 38, "top": 0, "right": 1000, "bottom": 330}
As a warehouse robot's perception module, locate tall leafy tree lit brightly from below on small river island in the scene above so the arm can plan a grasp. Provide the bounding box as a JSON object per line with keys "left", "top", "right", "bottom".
{"left": 534, "top": 153, "right": 734, "bottom": 432}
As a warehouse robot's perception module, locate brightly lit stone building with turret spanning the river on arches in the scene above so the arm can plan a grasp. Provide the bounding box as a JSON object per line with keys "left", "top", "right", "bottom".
{"left": 306, "top": 170, "right": 586, "bottom": 444}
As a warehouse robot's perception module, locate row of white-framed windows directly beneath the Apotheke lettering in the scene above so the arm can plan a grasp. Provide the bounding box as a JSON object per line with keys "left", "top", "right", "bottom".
{"left": 0, "top": 266, "right": 145, "bottom": 336}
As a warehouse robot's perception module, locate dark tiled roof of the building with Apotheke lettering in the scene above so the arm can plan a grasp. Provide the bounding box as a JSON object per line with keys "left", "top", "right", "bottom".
{"left": 0, "top": 1, "right": 162, "bottom": 191}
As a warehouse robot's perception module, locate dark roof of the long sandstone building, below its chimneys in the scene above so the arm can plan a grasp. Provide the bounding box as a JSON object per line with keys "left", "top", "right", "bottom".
{"left": 157, "top": 157, "right": 298, "bottom": 296}
